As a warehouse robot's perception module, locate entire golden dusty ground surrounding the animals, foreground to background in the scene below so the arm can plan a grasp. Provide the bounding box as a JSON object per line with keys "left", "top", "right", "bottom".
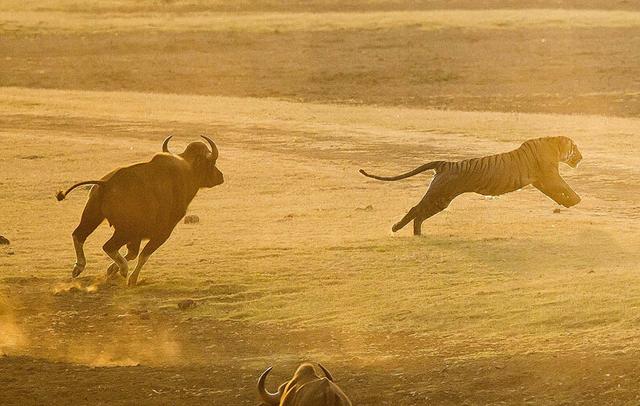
{"left": 0, "top": 0, "right": 640, "bottom": 405}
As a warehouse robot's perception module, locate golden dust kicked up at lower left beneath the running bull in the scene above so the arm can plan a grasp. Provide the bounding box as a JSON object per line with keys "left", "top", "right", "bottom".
{"left": 0, "top": 286, "right": 181, "bottom": 367}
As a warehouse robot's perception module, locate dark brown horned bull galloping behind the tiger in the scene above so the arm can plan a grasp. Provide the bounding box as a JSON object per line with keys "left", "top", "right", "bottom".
{"left": 57, "top": 137, "right": 224, "bottom": 285}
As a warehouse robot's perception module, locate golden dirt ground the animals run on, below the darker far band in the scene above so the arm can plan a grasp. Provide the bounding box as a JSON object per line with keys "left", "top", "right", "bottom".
{"left": 0, "top": 88, "right": 640, "bottom": 405}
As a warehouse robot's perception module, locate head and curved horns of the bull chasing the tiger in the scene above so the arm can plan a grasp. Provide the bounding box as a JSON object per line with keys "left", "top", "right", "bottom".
{"left": 162, "top": 135, "right": 224, "bottom": 187}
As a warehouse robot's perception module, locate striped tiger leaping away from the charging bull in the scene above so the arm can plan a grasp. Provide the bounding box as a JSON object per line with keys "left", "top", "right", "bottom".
{"left": 360, "top": 136, "right": 582, "bottom": 236}
